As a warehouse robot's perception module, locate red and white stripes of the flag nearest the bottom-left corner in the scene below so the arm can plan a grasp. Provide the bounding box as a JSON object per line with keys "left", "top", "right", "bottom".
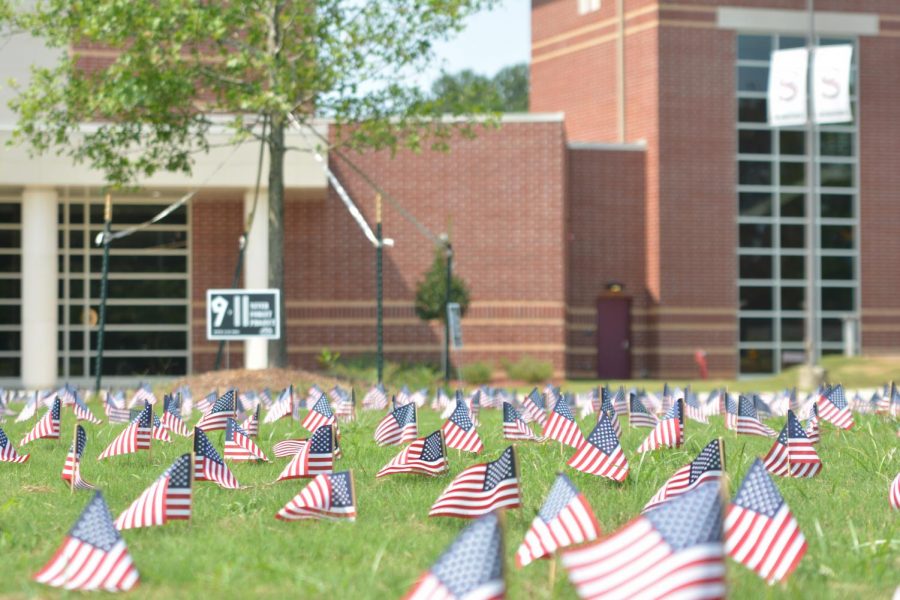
{"left": 34, "top": 538, "right": 138, "bottom": 592}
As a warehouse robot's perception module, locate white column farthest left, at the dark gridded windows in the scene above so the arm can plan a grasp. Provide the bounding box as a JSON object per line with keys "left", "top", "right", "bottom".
{"left": 22, "top": 187, "right": 59, "bottom": 388}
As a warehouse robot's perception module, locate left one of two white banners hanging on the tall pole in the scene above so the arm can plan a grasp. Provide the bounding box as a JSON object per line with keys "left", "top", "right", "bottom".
{"left": 768, "top": 48, "right": 808, "bottom": 127}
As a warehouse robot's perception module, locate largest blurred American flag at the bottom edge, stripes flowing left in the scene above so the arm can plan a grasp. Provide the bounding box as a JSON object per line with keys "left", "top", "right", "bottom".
{"left": 562, "top": 483, "right": 726, "bottom": 598}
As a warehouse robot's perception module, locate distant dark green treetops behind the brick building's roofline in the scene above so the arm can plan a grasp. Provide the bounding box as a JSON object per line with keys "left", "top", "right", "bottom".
{"left": 431, "top": 63, "right": 528, "bottom": 114}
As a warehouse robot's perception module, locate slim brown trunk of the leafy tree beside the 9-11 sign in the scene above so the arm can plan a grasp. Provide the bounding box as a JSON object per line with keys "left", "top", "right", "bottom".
{"left": 269, "top": 115, "right": 288, "bottom": 369}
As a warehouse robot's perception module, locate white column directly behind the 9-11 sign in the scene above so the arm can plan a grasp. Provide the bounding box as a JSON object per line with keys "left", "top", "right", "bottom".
{"left": 244, "top": 189, "right": 269, "bottom": 369}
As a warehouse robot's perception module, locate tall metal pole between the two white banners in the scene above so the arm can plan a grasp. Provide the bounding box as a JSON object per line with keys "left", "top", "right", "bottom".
{"left": 805, "top": 0, "right": 819, "bottom": 367}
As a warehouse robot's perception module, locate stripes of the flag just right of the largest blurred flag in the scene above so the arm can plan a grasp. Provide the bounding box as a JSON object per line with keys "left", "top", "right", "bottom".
{"left": 725, "top": 503, "right": 806, "bottom": 583}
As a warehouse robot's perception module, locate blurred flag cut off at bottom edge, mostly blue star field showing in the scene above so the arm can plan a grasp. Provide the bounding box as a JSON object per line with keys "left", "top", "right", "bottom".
{"left": 404, "top": 513, "right": 506, "bottom": 600}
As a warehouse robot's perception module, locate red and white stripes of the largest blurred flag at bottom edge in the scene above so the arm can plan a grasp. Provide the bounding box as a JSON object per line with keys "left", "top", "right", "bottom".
{"left": 563, "top": 518, "right": 725, "bottom": 598}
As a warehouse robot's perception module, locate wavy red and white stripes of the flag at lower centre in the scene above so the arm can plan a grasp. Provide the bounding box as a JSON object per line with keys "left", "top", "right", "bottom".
{"left": 428, "top": 465, "right": 521, "bottom": 518}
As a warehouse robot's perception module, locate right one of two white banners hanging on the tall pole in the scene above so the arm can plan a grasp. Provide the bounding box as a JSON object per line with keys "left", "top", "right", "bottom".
{"left": 813, "top": 44, "right": 853, "bottom": 124}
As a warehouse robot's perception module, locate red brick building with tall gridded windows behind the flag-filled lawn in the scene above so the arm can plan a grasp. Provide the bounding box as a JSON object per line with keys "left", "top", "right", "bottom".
{"left": 0, "top": 0, "right": 900, "bottom": 385}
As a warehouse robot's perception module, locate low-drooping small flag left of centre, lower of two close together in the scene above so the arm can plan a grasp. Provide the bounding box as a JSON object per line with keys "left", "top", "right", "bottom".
{"left": 275, "top": 471, "right": 356, "bottom": 521}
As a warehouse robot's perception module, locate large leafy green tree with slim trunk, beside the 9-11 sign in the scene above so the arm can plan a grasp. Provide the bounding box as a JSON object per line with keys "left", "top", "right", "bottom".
{"left": 0, "top": 0, "right": 496, "bottom": 367}
